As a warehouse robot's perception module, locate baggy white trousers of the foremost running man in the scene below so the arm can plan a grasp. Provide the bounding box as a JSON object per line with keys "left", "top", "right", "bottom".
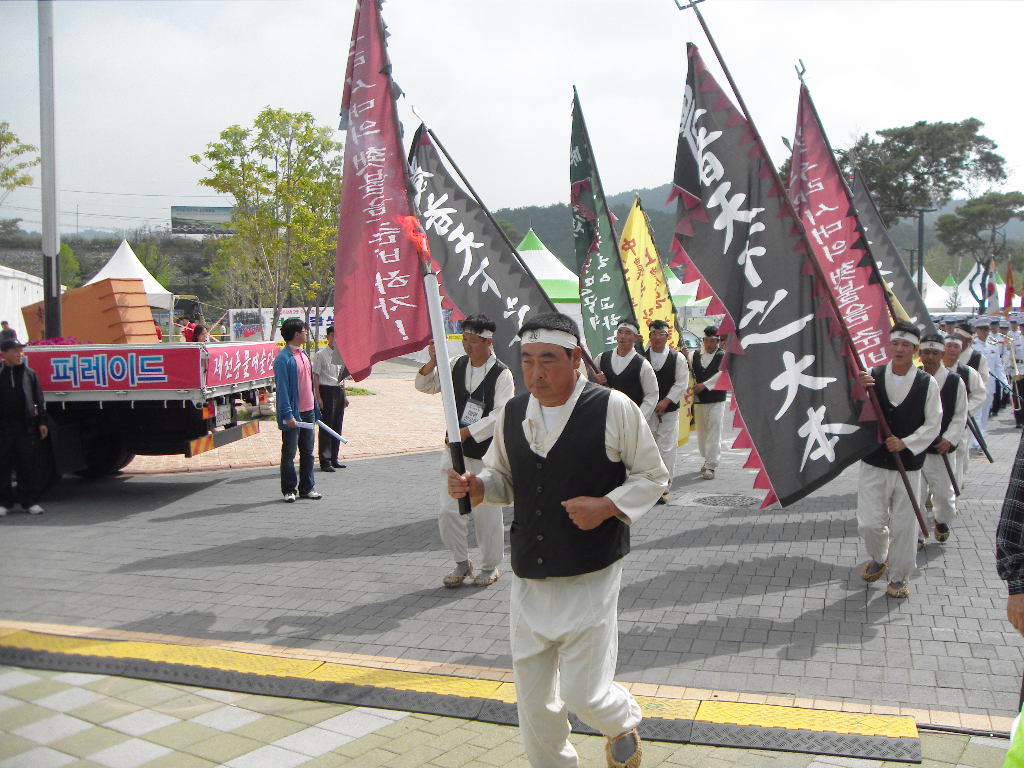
{"left": 510, "top": 560, "right": 641, "bottom": 768}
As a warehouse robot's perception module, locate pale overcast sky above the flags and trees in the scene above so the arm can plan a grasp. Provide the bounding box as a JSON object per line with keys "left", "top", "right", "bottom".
{"left": 0, "top": 0, "right": 1024, "bottom": 233}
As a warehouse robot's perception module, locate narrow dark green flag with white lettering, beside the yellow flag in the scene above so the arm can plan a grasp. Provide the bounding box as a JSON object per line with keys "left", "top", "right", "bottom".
{"left": 569, "top": 88, "right": 636, "bottom": 357}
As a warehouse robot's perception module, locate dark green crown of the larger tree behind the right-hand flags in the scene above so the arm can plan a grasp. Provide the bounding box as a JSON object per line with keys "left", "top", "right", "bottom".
{"left": 838, "top": 118, "right": 1007, "bottom": 226}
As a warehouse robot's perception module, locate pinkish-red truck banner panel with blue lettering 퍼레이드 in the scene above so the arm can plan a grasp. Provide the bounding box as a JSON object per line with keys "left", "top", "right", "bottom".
{"left": 26, "top": 345, "right": 201, "bottom": 392}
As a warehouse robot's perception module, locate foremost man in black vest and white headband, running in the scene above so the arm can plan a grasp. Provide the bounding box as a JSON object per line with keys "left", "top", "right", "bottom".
{"left": 449, "top": 313, "right": 668, "bottom": 768}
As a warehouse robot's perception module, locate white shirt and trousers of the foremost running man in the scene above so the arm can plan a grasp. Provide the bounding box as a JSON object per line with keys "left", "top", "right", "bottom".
{"left": 479, "top": 377, "right": 668, "bottom": 768}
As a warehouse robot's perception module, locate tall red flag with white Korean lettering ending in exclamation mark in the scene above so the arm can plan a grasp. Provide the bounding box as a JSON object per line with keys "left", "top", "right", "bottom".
{"left": 335, "top": 0, "right": 430, "bottom": 381}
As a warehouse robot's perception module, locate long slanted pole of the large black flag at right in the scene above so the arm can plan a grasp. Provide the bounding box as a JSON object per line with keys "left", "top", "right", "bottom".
{"left": 675, "top": 0, "right": 929, "bottom": 539}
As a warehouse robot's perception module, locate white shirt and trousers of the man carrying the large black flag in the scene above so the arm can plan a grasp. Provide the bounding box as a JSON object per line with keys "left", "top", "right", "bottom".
{"left": 857, "top": 362, "right": 942, "bottom": 582}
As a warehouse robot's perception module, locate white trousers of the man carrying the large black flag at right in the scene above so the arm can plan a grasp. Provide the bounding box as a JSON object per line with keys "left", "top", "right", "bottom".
{"left": 857, "top": 462, "right": 921, "bottom": 582}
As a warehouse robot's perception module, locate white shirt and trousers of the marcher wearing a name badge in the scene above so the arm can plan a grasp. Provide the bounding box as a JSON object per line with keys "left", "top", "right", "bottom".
{"left": 415, "top": 354, "right": 515, "bottom": 570}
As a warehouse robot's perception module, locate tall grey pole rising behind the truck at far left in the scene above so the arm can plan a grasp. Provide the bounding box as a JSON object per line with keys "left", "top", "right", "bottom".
{"left": 39, "top": 0, "right": 63, "bottom": 339}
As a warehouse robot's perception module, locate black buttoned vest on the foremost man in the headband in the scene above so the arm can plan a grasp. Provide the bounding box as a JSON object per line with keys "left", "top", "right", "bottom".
{"left": 504, "top": 382, "right": 630, "bottom": 579}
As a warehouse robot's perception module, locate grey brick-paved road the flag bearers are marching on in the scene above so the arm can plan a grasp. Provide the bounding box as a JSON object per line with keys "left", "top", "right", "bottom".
{"left": 0, "top": 358, "right": 1022, "bottom": 727}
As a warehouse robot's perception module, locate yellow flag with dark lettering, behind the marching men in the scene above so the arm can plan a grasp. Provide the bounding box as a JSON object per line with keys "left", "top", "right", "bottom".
{"left": 618, "top": 199, "right": 679, "bottom": 347}
